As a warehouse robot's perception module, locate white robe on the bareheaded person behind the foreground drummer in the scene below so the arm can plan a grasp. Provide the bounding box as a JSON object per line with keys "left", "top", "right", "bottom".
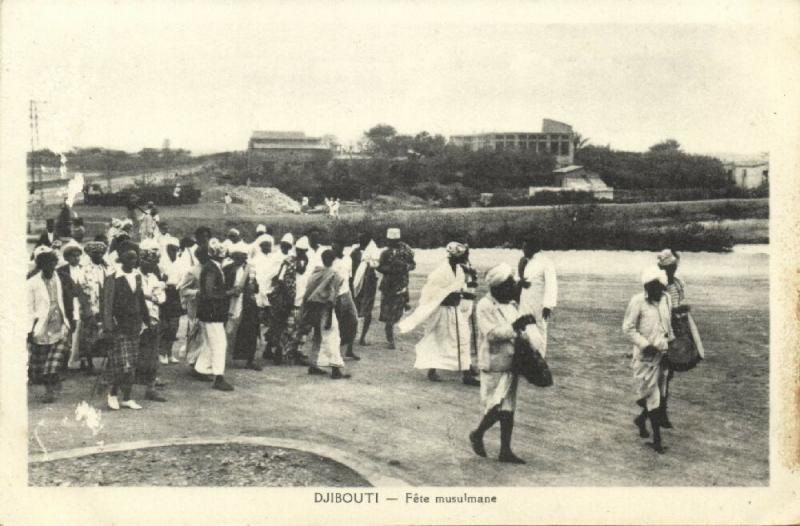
{"left": 519, "top": 252, "right": 558, "bottom": 357}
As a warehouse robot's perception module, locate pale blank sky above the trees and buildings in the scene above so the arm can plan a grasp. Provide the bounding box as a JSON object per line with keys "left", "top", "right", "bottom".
{"left": 3, "top": 1, "right": 788, "bottom": 153}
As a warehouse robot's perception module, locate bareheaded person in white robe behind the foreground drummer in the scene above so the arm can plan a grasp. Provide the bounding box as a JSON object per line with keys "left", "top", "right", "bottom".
{"left": 518, "top": 239, "right": 558, "bottom": 357}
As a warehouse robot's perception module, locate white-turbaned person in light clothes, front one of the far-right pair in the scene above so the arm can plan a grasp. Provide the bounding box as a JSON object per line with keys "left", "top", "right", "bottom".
{"left": 622, "top": 265, "right": 675, "bottom": 453}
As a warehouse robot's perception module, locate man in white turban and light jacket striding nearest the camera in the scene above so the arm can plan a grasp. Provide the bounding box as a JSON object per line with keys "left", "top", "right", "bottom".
{"left": 469, "top": 263, "right": 543, "bottom": 464}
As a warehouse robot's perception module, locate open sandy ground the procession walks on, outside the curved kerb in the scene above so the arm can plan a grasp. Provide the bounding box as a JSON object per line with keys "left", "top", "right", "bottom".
{"left": 29, "top": 251, "right": 769, "bottom": 486}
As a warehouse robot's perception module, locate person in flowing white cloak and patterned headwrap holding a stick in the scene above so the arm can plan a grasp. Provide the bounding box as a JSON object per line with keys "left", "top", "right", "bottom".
{"left": 397, "top": 242, "right": 472, "bottom": 382}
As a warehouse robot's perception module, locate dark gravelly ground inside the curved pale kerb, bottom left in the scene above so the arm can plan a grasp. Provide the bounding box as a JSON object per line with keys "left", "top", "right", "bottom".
{"left": 28, "top": 443, "right": 370, "bottom": 487}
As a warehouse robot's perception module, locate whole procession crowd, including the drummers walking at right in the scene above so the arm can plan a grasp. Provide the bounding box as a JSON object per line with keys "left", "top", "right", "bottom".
{"left": 28, "top": 204, "right": 702, "bottom": 463}
